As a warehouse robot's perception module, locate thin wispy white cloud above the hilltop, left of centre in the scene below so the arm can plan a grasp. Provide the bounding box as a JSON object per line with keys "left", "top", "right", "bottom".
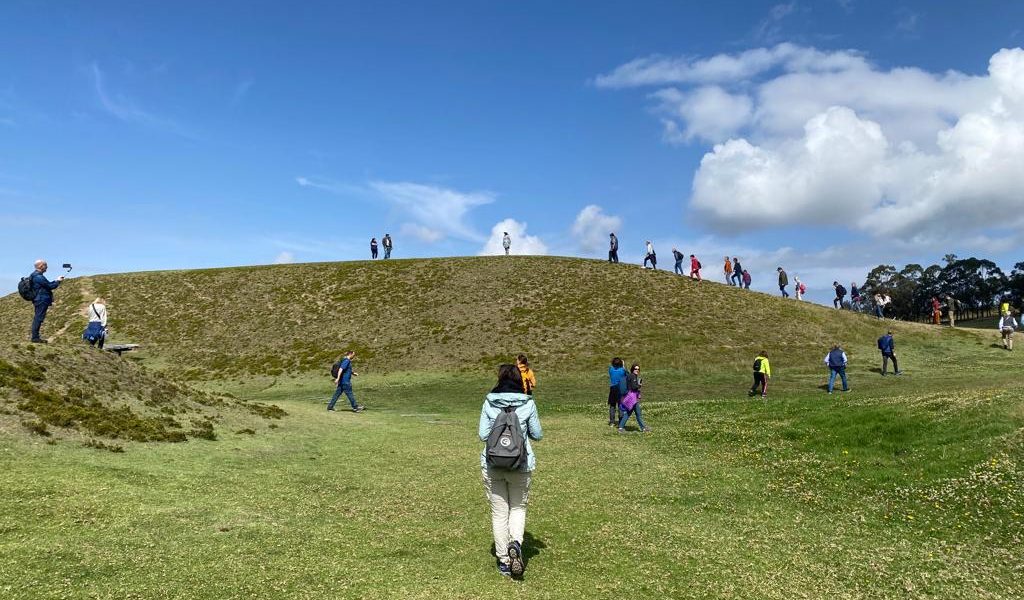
{"left": 295, "top": 176, "right": 495, "bottom": 243}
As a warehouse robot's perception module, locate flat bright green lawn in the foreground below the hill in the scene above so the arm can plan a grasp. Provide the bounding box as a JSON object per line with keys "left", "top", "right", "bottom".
{"left": 0, "top": 337, "right": 1024, "bottom": 598}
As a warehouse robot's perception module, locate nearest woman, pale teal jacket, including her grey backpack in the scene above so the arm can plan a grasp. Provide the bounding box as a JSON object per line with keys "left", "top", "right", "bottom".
{"left": 478, "top": 365, "right": 544, "bottom": 577}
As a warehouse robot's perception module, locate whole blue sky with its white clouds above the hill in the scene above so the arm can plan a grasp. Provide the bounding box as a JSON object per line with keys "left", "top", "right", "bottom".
{"left": 0, "top": 0, "right": 1024, "bottom": 295}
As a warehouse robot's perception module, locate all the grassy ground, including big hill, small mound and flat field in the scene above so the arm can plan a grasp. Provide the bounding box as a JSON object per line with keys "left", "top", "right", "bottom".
{"left": 0, "top": 257, "right": 1024, "bottom": 599}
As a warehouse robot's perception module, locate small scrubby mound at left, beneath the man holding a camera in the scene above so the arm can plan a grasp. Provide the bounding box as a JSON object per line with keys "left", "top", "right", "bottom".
{"left": 0, "top": 343, "right": 284, "bottom": 451}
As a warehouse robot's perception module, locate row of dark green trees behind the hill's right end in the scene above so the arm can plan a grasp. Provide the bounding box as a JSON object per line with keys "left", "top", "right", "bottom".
{"left": 861, "top": 254, "right": 1024, "bottom": 320}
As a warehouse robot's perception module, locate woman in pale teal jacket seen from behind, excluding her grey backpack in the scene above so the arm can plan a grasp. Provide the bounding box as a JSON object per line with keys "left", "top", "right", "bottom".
{"left": 478, "top": 365, "right": 544, "bottom": 577}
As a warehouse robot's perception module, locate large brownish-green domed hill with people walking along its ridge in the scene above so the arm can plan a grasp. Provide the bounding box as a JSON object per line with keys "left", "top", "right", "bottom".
{"left": 0, "top": 257, "right": 965, "bottom": 379}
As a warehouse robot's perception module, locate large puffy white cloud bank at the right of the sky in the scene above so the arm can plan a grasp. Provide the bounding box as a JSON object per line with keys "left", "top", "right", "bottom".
{"left": 598, "top": 44, "right": 1024, "bottom": 247}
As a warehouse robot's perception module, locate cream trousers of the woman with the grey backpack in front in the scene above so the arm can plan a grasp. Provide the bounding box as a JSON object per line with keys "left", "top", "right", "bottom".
{"left": 482, "top": 467, "right": 529, "bottom": 564}
